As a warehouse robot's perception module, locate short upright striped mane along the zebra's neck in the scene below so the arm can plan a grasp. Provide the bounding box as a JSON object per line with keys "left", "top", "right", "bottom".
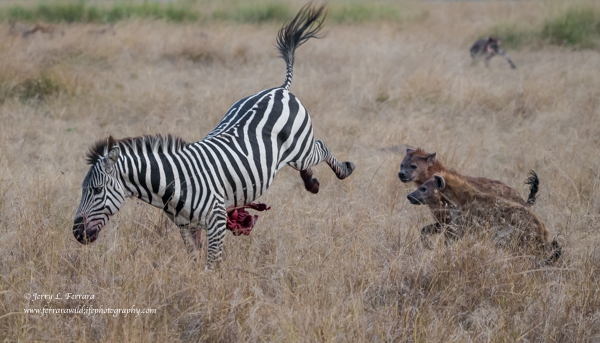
{"left": 86, "top": 134, "right": 188, "bottom": 165}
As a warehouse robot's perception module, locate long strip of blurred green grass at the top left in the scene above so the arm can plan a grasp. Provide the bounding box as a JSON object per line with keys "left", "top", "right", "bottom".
{"left": 2, "top": 2, "right": 200, "bottom": 23}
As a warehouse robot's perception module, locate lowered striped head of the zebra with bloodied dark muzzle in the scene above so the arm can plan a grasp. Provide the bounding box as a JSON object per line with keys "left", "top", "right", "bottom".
{"left": 73, "top": 136, "right": 125, "bottom": 244}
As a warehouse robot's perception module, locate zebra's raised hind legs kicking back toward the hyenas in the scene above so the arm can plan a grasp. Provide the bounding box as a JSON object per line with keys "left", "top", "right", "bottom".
{"left": 300, "top": 140, "right": 356, "bottom": 194}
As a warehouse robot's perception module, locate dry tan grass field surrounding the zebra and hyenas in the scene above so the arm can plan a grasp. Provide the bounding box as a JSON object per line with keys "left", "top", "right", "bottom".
{"left": 0, "top": 1, "right": 600, "bottom": 342}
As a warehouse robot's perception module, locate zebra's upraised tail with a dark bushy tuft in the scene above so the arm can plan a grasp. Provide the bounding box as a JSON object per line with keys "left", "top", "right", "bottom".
{"left": 277, "top": 3, "right": 327, "bottom": 90}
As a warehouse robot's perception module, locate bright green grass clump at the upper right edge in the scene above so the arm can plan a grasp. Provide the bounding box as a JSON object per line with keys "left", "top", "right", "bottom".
{"left": 541, "top": 7, "right": 600, "bottom": 48}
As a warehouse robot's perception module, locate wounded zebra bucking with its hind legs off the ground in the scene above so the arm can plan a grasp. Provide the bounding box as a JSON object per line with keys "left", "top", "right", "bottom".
{"left": 73, "top": 4, "right": 355, "bottom": 269}
